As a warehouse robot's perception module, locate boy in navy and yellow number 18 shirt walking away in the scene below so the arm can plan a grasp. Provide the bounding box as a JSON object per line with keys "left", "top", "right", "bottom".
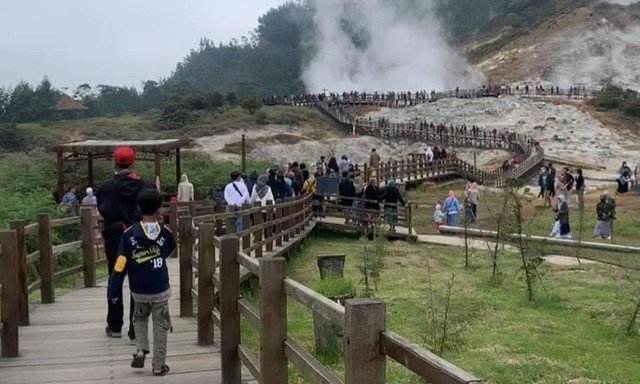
{"left": 108, "top": 189, "right": 176, "bottom": 376}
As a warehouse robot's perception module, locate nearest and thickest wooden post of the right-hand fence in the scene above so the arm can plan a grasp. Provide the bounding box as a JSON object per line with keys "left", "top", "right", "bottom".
{"left": 344, "top": 299, "right": 386, "bottom": 384}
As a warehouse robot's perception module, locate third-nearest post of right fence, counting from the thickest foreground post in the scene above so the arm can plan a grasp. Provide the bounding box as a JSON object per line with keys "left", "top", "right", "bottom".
{"left": 220, "top": 236, "right": 242, "bottom": 384}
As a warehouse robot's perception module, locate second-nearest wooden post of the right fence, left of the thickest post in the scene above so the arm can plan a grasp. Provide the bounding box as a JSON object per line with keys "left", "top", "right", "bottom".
{"left": 260, "top": 257, "right": 288, "bottom": 384}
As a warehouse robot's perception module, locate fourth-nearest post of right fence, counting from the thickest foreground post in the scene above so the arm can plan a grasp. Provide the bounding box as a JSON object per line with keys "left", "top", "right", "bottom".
{"left": 198, "top": 223, "right": 216, "bottom": 345}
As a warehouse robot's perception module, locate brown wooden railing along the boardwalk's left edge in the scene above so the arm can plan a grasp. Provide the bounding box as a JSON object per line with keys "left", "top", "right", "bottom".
{"left": 0, "top": 207, "right": 104, "bottom": 357}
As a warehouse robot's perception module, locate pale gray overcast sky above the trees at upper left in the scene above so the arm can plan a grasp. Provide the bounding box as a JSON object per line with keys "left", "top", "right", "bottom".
{"left": 0, "top": 0, "right": 285, "bottom": 89}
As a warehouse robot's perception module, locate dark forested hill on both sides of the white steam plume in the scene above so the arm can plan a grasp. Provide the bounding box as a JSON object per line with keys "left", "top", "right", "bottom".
{"left": 167, "top": 0, "right": 593, "bottom": 95}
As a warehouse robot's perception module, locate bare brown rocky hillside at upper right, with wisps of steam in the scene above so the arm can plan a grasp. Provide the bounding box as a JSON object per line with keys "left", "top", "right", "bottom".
{"left": 476, "top": 3, "right": 640, "bottom": 89}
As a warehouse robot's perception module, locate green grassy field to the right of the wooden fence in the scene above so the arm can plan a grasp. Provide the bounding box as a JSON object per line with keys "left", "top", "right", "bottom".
{"left": 242, "top": 234, "right": 640, "bottom": 384}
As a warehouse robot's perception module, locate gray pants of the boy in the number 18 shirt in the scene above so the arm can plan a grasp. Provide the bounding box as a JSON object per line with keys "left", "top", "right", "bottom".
{"left": 133, "top": 301, "right": 171, "bottom": 370}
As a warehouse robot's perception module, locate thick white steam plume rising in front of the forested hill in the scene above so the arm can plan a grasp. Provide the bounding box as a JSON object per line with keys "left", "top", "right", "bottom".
{"left": 302, "top": 0, "right": 484, "bottom": 92}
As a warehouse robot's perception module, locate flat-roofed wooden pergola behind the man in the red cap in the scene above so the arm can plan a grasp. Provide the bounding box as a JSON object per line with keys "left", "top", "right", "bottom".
{"left": 55, "top": 139, "right": 189, "bottom": 198}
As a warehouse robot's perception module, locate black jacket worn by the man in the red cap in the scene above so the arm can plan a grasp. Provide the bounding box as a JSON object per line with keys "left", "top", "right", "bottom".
{"left": 96, "top": 172, "right": 156, "bottom": 227}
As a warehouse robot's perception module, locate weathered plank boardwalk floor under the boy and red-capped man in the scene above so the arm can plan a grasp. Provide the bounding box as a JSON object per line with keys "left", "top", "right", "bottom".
{"left": 0, "top": 259, "right": 254, "bottom": 384}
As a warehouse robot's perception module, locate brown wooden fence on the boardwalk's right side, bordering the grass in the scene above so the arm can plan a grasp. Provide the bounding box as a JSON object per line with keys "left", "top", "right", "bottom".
{"left": 178, "top": 197, "right": 482, "bottom": 384}
